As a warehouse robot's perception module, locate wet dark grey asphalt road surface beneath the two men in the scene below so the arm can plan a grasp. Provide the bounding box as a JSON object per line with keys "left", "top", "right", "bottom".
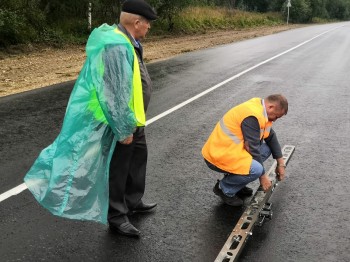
{"left": 0, "top": 23, "right": 350, "bottom": 262}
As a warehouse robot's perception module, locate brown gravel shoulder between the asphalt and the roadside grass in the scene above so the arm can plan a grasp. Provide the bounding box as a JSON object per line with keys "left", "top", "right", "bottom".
{"left": 0, "top": 25, "right": 305, "bottom": 97}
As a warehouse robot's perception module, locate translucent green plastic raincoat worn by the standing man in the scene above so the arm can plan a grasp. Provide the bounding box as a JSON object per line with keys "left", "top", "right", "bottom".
{"left": 24, "top": 24, "right": 145, "bottom": 224}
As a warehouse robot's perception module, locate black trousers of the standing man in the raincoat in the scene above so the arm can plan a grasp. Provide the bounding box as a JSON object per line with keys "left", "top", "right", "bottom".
{"left": 108, "top": 128, "right": 147, "bottom": 223}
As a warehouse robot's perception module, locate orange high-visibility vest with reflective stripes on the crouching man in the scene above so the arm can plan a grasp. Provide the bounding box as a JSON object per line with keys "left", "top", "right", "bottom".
{"left": 202, "top": 98, "right": 272, "bottom": 175}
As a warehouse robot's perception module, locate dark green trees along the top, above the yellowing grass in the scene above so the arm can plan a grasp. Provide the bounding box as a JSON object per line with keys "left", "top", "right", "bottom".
{"left": 0, "top": 0, "right": 350, "bottom": 46}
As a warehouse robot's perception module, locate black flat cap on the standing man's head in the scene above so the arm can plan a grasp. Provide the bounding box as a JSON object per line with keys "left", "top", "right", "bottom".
{"left": 122, "top": 0, "right": 158, "bottom": 21}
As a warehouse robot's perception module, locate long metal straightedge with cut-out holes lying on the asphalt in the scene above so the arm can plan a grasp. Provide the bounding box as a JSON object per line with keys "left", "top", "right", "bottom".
{"left": 215, "top": 145, "right": 295, "bottom": 262}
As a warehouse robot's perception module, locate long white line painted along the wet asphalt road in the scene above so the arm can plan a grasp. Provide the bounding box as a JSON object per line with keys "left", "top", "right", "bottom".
{"left": 0, "top": 25, "right": 344, "bottom": 202}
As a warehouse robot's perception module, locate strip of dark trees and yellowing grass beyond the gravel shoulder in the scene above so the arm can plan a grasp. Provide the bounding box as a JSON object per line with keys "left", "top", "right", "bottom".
{"left": 0, "top": 0, "right": 350, "bottom": 47}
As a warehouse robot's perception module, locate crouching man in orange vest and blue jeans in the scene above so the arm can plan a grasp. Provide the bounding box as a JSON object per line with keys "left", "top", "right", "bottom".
{"left": 202, "top": 94, "right": 288, "bottom": 206}
